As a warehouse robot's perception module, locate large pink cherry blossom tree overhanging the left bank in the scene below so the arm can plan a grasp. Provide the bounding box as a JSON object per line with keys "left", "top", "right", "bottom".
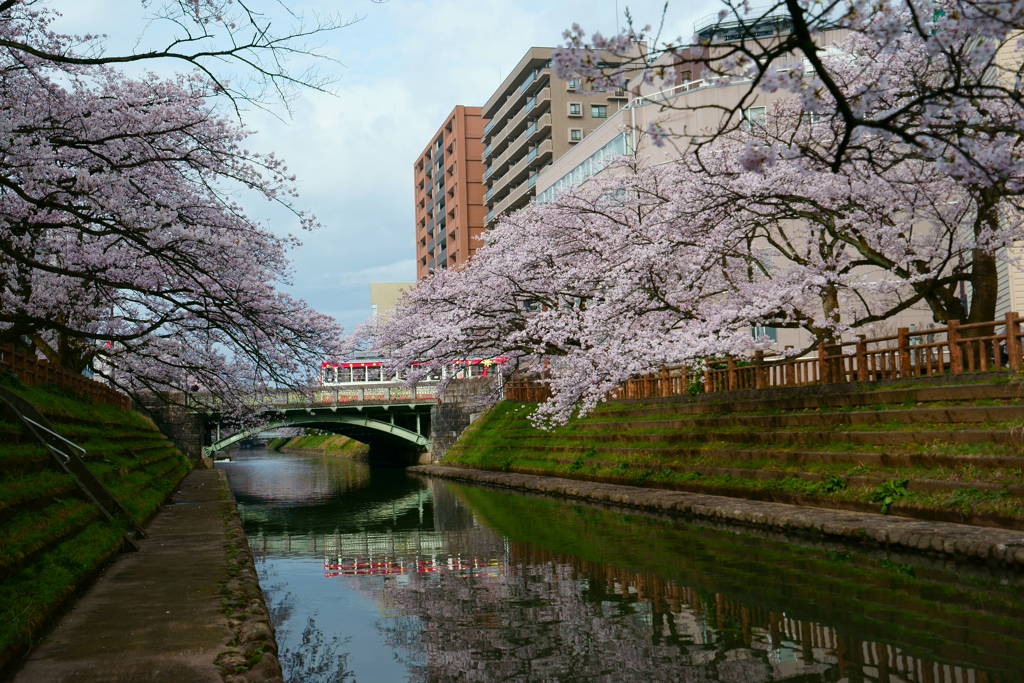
{"left": 0, "top": 0, "right": 350, "bottom": 413}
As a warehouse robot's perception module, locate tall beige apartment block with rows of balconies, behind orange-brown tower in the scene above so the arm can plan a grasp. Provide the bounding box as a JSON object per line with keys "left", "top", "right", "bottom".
{"left": 482, "top": 47, "right": 627, "bottom": 227}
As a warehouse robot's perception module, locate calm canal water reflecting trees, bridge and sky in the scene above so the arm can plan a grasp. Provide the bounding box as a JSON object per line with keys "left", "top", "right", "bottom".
{"left": 218, "top": 451, "right": 1024, "bottom": 683}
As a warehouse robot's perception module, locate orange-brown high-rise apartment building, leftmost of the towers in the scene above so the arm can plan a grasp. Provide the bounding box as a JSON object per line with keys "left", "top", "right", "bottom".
{"left": 413, "top": 104, "right": 485, "bottom": 280}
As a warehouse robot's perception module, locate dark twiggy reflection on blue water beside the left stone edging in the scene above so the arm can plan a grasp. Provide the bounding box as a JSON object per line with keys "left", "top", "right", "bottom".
{"left": 260, "top": 567, "right": 355, "bottom": 683}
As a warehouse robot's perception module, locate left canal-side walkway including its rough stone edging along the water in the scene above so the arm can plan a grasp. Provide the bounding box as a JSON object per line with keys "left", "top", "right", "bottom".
{"left": 14, "top": 470, "right": 282, "bottom": 683}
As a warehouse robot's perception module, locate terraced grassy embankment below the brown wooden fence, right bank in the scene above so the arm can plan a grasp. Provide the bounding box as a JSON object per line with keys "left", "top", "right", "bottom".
{"left": 443, "top": 374, "right": 1024, "bottom": 529}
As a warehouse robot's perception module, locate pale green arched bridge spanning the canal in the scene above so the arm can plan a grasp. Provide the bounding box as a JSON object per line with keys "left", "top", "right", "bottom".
{"left": 203, "top": 382, "right": 437, "bottom": 456}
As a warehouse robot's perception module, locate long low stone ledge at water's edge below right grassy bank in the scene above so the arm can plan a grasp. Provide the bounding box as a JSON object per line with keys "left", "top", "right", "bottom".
{"left": 410, "top": 465, "right": 1024, "bottom": 569}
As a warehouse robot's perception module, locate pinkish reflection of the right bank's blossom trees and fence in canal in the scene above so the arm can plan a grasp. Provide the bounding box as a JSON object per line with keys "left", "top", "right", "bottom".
{"left": 362, "top": 543, "right": 1013, "bottom": 683}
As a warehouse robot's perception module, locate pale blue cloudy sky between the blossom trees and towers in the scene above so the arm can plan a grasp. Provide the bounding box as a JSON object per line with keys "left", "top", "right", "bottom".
{"left": 49, "top": 0, "right": 718, "bottom": 330}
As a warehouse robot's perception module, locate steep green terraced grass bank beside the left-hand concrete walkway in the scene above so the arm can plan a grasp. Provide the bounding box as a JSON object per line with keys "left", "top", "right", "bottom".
{"left": 0, "top": 381, "right": 190, "bottom": 670}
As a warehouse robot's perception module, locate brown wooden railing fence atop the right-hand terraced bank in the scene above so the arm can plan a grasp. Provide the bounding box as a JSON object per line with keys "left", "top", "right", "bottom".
{"left": 505, "top": 313, "right": 1024, "bottom": 401}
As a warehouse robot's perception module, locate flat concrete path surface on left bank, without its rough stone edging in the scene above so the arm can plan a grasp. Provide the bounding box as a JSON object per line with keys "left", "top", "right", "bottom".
{"left": 14, "top": 470, "right": 234, "bottom": 683}
